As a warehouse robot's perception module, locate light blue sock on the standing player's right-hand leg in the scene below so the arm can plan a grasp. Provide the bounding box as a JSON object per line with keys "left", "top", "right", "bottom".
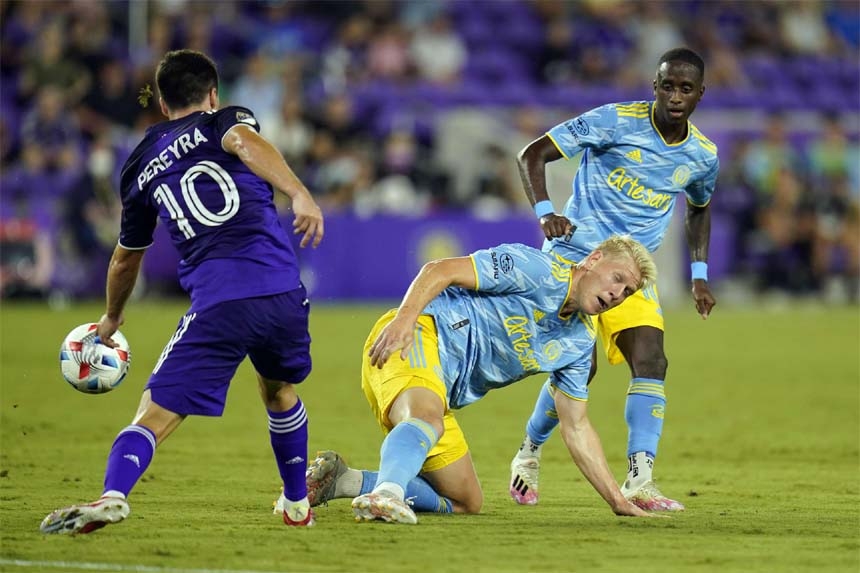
{"left": 624, "top": 378, "right": 666, "bottom": 458}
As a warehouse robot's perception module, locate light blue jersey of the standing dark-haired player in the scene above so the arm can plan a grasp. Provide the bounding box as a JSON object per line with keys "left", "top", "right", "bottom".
{"left": 544, "top": 101, "right": 720, "bottom": 261}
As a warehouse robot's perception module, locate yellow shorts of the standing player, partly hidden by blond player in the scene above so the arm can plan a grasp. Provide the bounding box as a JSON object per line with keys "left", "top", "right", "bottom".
{"left": 597, "top": 285, "right": 663, "bottom": 364}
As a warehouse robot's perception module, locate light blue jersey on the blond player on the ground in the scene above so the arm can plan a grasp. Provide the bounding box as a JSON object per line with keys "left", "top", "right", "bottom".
{"left": 423, "top": 244, "right": 595, "bottom": 409}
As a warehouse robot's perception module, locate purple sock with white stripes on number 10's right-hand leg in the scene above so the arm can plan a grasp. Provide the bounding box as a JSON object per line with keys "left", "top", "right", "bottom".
{"left": 268, "top": 400, "right": 308, "bottom": 501}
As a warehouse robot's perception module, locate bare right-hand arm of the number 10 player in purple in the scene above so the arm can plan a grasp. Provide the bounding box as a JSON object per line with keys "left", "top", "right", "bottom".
{"left": 222, "top": 124, "right": 324, "bottom": 247}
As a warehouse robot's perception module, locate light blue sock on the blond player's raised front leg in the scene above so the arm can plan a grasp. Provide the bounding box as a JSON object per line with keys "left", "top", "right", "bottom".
{"left": 376, "top": 418, "right": 439, "bottom": 492}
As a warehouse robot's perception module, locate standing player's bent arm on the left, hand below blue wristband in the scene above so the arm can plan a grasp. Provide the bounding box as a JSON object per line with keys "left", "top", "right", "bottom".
{"left": 517, "top": 135, "right": 576, "bottom": 239}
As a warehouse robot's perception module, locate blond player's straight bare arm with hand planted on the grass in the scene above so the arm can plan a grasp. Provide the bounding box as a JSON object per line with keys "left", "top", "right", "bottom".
{"left": 555, "top": 392, "right": 651, "bottom": 517}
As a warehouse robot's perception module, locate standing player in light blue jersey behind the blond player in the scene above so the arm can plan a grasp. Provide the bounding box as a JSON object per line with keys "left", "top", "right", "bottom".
{"left": 510, "top": 48, "right": 719, "bottom": 511}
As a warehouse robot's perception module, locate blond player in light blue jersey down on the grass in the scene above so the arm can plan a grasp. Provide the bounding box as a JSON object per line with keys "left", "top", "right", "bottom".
{"left": 288, "top": 236, "right": 656, "bottom": 523}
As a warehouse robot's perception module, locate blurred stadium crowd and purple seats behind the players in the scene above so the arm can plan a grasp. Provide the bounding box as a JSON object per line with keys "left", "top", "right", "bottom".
{"left": 0, "top": 0, "right": 860, "bottom": 297}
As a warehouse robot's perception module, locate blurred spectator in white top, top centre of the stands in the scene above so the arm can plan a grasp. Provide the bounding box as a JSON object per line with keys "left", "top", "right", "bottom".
{"left": 410, "top": 13, "right": 467, "bottom": 85}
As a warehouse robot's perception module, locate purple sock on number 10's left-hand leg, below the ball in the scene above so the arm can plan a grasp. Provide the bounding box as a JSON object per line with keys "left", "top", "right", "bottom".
{"left": 104, "top": 425, "right": 156, "bottom": 497}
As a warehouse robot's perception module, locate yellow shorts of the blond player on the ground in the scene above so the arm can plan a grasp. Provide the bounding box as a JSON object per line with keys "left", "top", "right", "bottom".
{"left": 361, "top": 310, "right": 469, "bottom": 472}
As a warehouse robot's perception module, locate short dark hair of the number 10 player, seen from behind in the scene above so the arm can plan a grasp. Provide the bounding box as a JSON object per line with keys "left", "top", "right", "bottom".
{"left": 155, "top": 50, "right": 218, "bottom": 109}
